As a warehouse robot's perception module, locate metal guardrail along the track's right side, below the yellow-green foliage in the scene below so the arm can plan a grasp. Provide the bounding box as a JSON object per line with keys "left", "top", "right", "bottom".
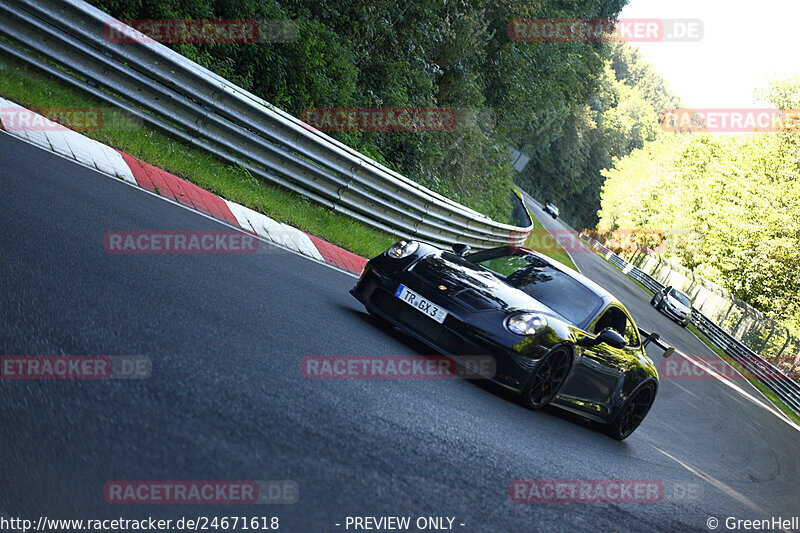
{"left": 580, "top": 233, "right": 800, "bottom": 414}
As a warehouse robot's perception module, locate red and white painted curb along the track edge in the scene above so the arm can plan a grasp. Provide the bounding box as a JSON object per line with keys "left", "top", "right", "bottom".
{"left": 0, "top": 98, "right": 367, "bottom": 274}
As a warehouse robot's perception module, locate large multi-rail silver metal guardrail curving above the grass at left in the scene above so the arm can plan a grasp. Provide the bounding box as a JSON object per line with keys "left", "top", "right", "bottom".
{"left": 0, "top": 0, "right": 533, "bottom": 248}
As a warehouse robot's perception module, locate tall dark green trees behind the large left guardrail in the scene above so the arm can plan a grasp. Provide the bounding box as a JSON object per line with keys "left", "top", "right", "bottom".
{"left": 86, "top": 0, "right": 670, "bottom": 225}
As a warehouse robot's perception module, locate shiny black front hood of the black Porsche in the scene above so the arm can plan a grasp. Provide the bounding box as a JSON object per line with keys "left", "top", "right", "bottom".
{"left": 411, "top": 252, "right": 563, "bottom": 319}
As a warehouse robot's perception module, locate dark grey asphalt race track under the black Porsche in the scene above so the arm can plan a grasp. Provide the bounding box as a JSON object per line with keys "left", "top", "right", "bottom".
{"left": 0, "top": 130, "right": 800, "bottom": 532}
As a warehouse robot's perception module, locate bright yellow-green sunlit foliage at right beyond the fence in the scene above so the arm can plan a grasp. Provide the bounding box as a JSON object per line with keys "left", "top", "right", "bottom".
{"left": 600, "top": 77, "right": 800, "bottom": 333}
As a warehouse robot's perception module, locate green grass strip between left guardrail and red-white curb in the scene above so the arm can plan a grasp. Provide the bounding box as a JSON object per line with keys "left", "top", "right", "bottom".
{"left": 0, "top": 52, "right": 397, "bottom": 257}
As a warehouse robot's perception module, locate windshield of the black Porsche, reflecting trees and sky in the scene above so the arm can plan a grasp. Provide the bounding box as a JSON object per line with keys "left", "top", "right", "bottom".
{"left": 469, "top": 251, "right": 603, "bottom": 325}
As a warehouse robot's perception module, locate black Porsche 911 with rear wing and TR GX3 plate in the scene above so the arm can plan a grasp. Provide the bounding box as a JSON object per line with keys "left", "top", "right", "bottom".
{"left": 350, "top": 241, "right": 673, "bottom": 440}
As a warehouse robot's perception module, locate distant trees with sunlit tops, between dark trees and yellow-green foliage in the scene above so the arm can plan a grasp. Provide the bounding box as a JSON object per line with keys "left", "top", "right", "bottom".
{"left": 520, "top": 43, "right": 681, "bottom": 228}
